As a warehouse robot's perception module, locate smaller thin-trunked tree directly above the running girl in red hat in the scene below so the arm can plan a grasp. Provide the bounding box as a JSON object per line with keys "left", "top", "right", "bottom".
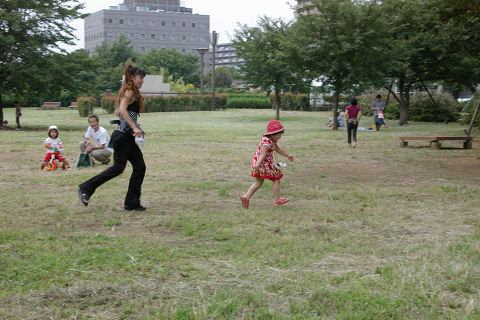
{"left": 233, "top": 17, "right": 303, "bottom": 120}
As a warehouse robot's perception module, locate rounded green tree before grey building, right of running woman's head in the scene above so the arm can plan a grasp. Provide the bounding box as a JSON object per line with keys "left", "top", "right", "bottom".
{"left": 140, "top": 49, "right": 200, "bottom": 86}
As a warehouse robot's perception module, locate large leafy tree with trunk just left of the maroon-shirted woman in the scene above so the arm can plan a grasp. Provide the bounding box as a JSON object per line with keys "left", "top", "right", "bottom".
{"left": 285, "top": 0, "right": 386, "bottom": 130}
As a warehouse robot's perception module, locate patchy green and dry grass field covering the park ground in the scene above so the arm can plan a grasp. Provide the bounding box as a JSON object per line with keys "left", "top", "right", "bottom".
{"left": 0, "top": 109, "right": 480, "bottom": 319}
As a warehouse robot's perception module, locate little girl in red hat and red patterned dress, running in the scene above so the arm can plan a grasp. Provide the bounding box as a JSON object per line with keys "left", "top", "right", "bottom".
{"left": 240, "top": 120, "right": 295, "bottom": 209}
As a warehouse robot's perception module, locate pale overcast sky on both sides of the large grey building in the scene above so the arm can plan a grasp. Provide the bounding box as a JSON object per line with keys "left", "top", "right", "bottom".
{"left": 65, "top": 0, "right": 296, "bottom": 51}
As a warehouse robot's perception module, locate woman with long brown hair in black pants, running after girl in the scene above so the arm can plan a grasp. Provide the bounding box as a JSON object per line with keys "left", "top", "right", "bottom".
{"left": 78, "top": 65, "right": 146, "bottom": 211}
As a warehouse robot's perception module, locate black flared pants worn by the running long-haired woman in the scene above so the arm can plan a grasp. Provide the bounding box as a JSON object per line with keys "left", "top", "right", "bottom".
{"left": 79, "top": 134, "right": 146, "bottom": 208}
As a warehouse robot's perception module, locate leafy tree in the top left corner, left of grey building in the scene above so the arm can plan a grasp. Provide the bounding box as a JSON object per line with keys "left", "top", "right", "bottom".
{"left": 0, "top": 0, "right": 83, "bottom": 109}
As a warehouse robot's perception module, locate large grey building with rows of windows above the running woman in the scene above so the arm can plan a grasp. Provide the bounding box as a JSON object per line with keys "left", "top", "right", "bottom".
{"left": 85, "top": 0, "right": 210, "bottom": 55}
